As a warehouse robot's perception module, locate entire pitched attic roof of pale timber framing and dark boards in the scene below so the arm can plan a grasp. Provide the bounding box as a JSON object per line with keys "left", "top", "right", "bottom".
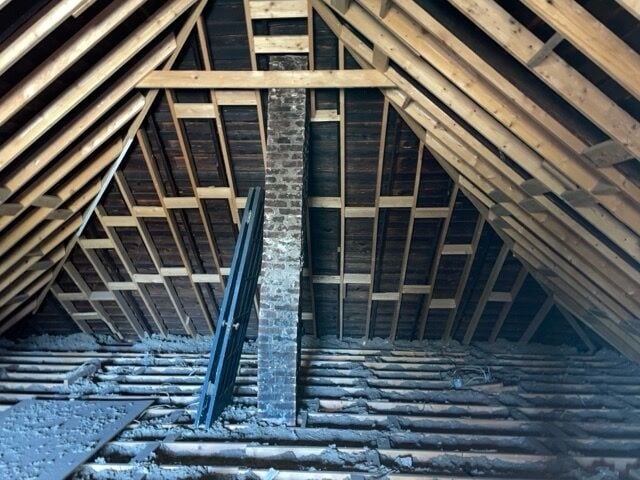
{"left": 0, "top": 0, "right": 640, "bottom": 359}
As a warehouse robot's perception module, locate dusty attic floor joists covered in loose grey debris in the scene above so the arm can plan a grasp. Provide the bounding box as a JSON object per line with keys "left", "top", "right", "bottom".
{"left": 0, "top": 334, "right": 640, "bottom": 480}
